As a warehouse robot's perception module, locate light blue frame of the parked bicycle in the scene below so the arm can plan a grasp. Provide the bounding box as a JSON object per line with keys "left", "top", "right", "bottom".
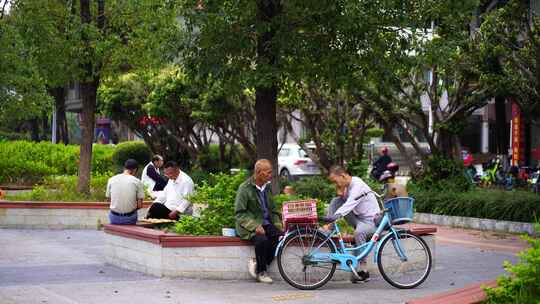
{"left": 275, "top": 212, "right": 407, "bottom": 272}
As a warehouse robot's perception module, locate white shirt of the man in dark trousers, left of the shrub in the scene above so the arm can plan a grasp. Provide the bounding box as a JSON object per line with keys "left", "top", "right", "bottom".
{"left": 154, "top": 171, "right": 195, "bottom": 214}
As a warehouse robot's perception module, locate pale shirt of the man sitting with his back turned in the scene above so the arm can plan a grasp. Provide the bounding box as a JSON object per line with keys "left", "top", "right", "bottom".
{"left": 105, "top": 173, "right": 144, "bottom": 213}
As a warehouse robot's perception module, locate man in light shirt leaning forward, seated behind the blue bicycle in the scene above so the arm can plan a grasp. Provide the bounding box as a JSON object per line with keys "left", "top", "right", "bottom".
{"left": 326, "top": 166, "right": 381, "bottom": 283}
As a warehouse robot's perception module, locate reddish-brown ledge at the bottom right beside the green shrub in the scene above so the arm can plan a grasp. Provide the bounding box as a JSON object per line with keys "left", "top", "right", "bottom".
{"left": 406, "top": 280, "right": 497, "bottom": 304}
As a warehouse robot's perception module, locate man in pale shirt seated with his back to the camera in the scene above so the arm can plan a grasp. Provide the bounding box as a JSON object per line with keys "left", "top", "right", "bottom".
{"left": 105, "top": 159, "right": 144, "bottom": 225}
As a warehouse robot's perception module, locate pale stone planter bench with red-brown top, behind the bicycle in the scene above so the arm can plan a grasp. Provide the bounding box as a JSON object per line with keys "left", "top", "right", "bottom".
{"left": 104, "top": 225, "right": 436, "bottom": 280}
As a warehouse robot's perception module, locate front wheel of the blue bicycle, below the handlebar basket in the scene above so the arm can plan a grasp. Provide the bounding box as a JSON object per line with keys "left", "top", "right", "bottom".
{"left": 377, "top": 232, "right": 432, "bottom": 289}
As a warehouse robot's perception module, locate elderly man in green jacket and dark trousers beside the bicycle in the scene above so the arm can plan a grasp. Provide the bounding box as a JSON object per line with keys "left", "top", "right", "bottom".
{"left": 235, "top": 159, "right": 282, "bottom": 283}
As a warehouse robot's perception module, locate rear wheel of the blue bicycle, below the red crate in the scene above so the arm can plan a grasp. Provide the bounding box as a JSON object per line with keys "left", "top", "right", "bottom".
{"left": 277, "top": 229, "right": 336, "bottom": 290}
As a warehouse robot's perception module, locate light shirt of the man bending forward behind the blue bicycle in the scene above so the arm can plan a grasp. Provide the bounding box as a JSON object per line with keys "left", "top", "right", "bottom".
{"left": 335, "top": 176, "right": 381, "bottom": 218}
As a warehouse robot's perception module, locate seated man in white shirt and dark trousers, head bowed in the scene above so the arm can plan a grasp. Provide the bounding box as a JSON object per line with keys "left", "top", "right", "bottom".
{"left": 146, "top": 161, "right": 195, "bottom": 220}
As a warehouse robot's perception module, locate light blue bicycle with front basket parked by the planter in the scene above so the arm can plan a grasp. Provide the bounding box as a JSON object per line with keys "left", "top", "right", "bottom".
{"left": 276, "top": 192, "right": 432, "bottom": 290}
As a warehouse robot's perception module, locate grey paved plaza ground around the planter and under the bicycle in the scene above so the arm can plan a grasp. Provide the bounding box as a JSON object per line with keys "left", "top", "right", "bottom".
{"left": 0, "top": 227, "right": 525, "bottom": 304}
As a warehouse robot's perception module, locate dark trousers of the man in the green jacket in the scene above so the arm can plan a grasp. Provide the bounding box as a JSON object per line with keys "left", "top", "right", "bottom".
{"left": 251, "top": 224, "right": 281, "bottom": 273}
